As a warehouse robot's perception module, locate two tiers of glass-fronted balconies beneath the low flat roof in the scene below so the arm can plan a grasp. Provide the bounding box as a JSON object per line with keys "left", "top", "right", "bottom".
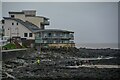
{"left": 35, "top": 34, "right": 74, "bottom": 43}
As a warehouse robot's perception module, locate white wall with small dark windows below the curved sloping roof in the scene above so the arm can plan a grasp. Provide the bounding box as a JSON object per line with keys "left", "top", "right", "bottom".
{"left": 4, "top": 20, "right": 35, "bottom": 39}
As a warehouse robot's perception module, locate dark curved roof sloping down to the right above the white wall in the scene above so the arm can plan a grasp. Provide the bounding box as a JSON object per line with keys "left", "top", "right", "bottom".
{"left": 3, "top": 17, "right": 40, "bottom": 33}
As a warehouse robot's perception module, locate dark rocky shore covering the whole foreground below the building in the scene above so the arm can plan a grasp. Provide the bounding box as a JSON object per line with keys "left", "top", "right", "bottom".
{"left": 2, "top": 48, "right": 120, "bottom": 80}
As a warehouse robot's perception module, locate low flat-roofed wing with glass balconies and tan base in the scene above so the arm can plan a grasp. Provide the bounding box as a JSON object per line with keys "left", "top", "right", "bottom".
{"left": 35, "top": 29, "right": 75, "bottom": 47}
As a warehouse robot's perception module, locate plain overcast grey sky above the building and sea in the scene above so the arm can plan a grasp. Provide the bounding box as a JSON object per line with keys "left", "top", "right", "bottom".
{"left": 2, "top": 2, "right": 118, "bottom": 44}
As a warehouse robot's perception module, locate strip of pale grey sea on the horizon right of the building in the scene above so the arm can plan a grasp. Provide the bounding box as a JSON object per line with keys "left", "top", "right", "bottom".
{"left": 76, "top": 43, "right": 120, "bottom": 49}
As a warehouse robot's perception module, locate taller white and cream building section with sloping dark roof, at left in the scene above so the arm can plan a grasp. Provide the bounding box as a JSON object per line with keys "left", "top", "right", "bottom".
{"left": 3, "top": 10, "right": 49, "bottom": 46}
